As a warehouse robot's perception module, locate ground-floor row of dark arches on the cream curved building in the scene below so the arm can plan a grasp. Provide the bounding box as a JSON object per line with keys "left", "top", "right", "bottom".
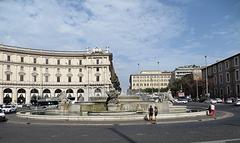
{"left": 0, "top": 87, "right": 108, "bottom": 104}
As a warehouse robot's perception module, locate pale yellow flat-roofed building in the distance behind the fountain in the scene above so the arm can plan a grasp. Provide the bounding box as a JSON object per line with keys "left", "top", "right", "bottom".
{"left": 129, "top": 70, "right": 171, "bottom": 92}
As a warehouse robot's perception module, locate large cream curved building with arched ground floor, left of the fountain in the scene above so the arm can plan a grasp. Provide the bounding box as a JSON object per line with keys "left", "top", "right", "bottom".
{"left": 0, "top": 44, "right": 120, "bottom": 104}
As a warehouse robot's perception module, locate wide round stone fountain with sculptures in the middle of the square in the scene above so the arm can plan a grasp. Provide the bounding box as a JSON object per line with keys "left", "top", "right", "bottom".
{"left": 18, "top": 88, "right": 205, "bottom": 121}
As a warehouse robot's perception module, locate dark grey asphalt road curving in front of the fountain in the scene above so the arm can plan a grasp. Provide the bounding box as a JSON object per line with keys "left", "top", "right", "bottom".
{"left": 0, "top": 104, "right": 240, "bottom": 143}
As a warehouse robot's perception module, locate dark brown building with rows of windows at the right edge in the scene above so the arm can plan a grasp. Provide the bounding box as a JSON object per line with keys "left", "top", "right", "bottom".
{"left": 202, "top": 53, "right": 240, "bottom": 98}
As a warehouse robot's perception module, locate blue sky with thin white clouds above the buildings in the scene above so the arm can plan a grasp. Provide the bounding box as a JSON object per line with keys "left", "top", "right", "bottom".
{"left": 0, "top": 0, "right": 240, "bottom": 91}
